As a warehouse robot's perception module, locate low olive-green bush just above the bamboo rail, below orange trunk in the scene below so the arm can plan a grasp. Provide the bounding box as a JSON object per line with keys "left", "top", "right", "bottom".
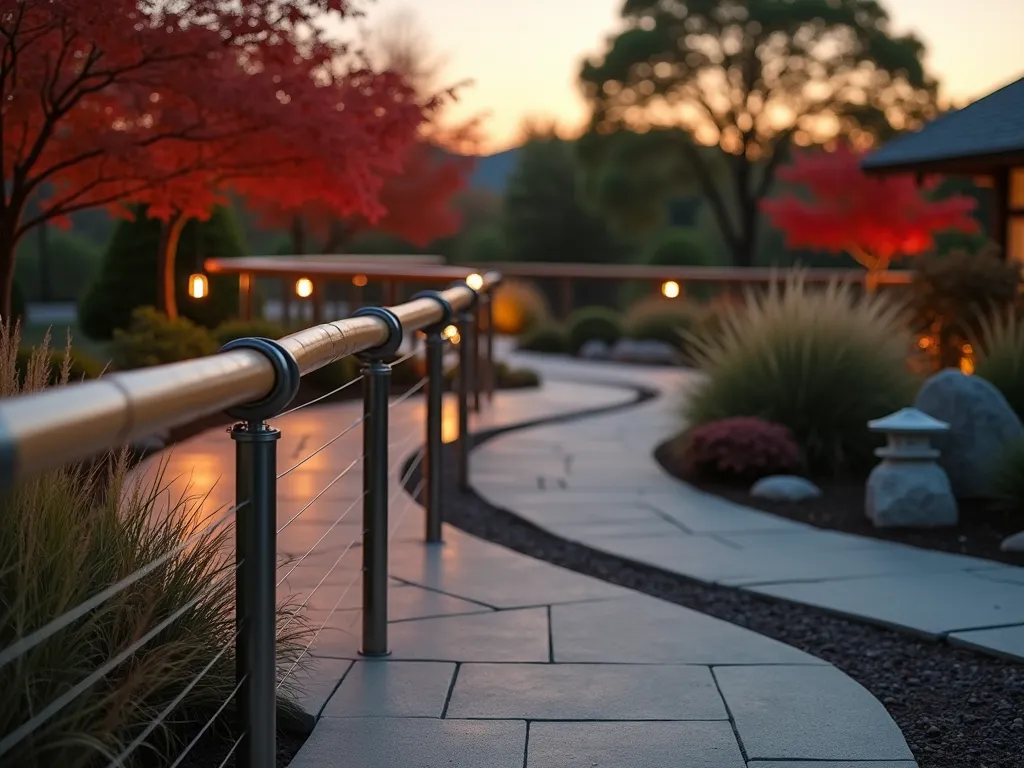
{"left": 111, "top": 306, "right": 217, "bottom": 371}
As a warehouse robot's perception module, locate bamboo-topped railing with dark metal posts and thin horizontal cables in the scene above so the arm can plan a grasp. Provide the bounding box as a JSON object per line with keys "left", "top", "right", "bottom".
{"left": 0, "top": 266, "right": 500, "bottom": 768}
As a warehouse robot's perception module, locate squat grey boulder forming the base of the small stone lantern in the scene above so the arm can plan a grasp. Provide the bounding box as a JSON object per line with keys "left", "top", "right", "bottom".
{"left": 864, "top": 460, "right": 958, "bottom": 528}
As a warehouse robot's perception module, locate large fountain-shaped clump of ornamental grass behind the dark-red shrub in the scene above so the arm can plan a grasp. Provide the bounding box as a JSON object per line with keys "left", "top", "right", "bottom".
{"left": 683, "top": 273, "right": 918, "bottom": 474}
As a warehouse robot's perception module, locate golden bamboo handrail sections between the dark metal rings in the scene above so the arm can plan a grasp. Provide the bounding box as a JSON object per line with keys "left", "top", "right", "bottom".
{"left": 0, "top": 274, "right": 501, "bottom": 485}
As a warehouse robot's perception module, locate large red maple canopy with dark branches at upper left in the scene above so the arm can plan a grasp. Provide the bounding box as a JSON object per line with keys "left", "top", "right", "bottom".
{"left": 0, "top": 0, "right": 432, "bottom": 315}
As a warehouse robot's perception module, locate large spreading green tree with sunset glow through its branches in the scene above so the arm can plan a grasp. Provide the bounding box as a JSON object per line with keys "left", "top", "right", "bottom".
{"left": 581, "top": 0, "right": 937, "bottom": 266}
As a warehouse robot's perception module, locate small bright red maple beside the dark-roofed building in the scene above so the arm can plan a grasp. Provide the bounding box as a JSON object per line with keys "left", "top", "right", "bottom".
{"left": 761, "top": 145, "right": 979, "bottom": 273}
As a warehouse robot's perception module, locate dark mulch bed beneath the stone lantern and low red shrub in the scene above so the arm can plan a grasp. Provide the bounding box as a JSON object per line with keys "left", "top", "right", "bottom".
{"left": 654, "top": 440, "right": 1024, "bottom": 569}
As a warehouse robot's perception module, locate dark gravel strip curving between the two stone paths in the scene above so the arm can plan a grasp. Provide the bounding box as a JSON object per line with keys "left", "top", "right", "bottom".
{"left": 403, "top": 381, "right": 1024, "bottom": 768}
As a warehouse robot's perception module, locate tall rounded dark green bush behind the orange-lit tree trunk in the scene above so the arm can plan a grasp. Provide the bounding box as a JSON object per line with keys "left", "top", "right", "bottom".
{"left": 79, "top": 208, "right": 246, "bottom": 339}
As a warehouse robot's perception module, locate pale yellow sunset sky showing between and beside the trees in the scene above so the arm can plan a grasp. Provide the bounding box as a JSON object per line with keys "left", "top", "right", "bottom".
{"left": 354, "top": 0, "right": 1024, "bottom": 152}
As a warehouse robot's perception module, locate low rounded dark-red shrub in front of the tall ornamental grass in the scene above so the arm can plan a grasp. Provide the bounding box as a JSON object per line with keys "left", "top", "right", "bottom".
{"left": 679, "top": 416, "right": 803, "bottom": 484}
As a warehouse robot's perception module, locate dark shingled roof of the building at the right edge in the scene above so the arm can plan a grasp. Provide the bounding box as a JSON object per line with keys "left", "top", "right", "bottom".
{"left": 861, "top": 72, "right": 1024, "bottom": 172}
